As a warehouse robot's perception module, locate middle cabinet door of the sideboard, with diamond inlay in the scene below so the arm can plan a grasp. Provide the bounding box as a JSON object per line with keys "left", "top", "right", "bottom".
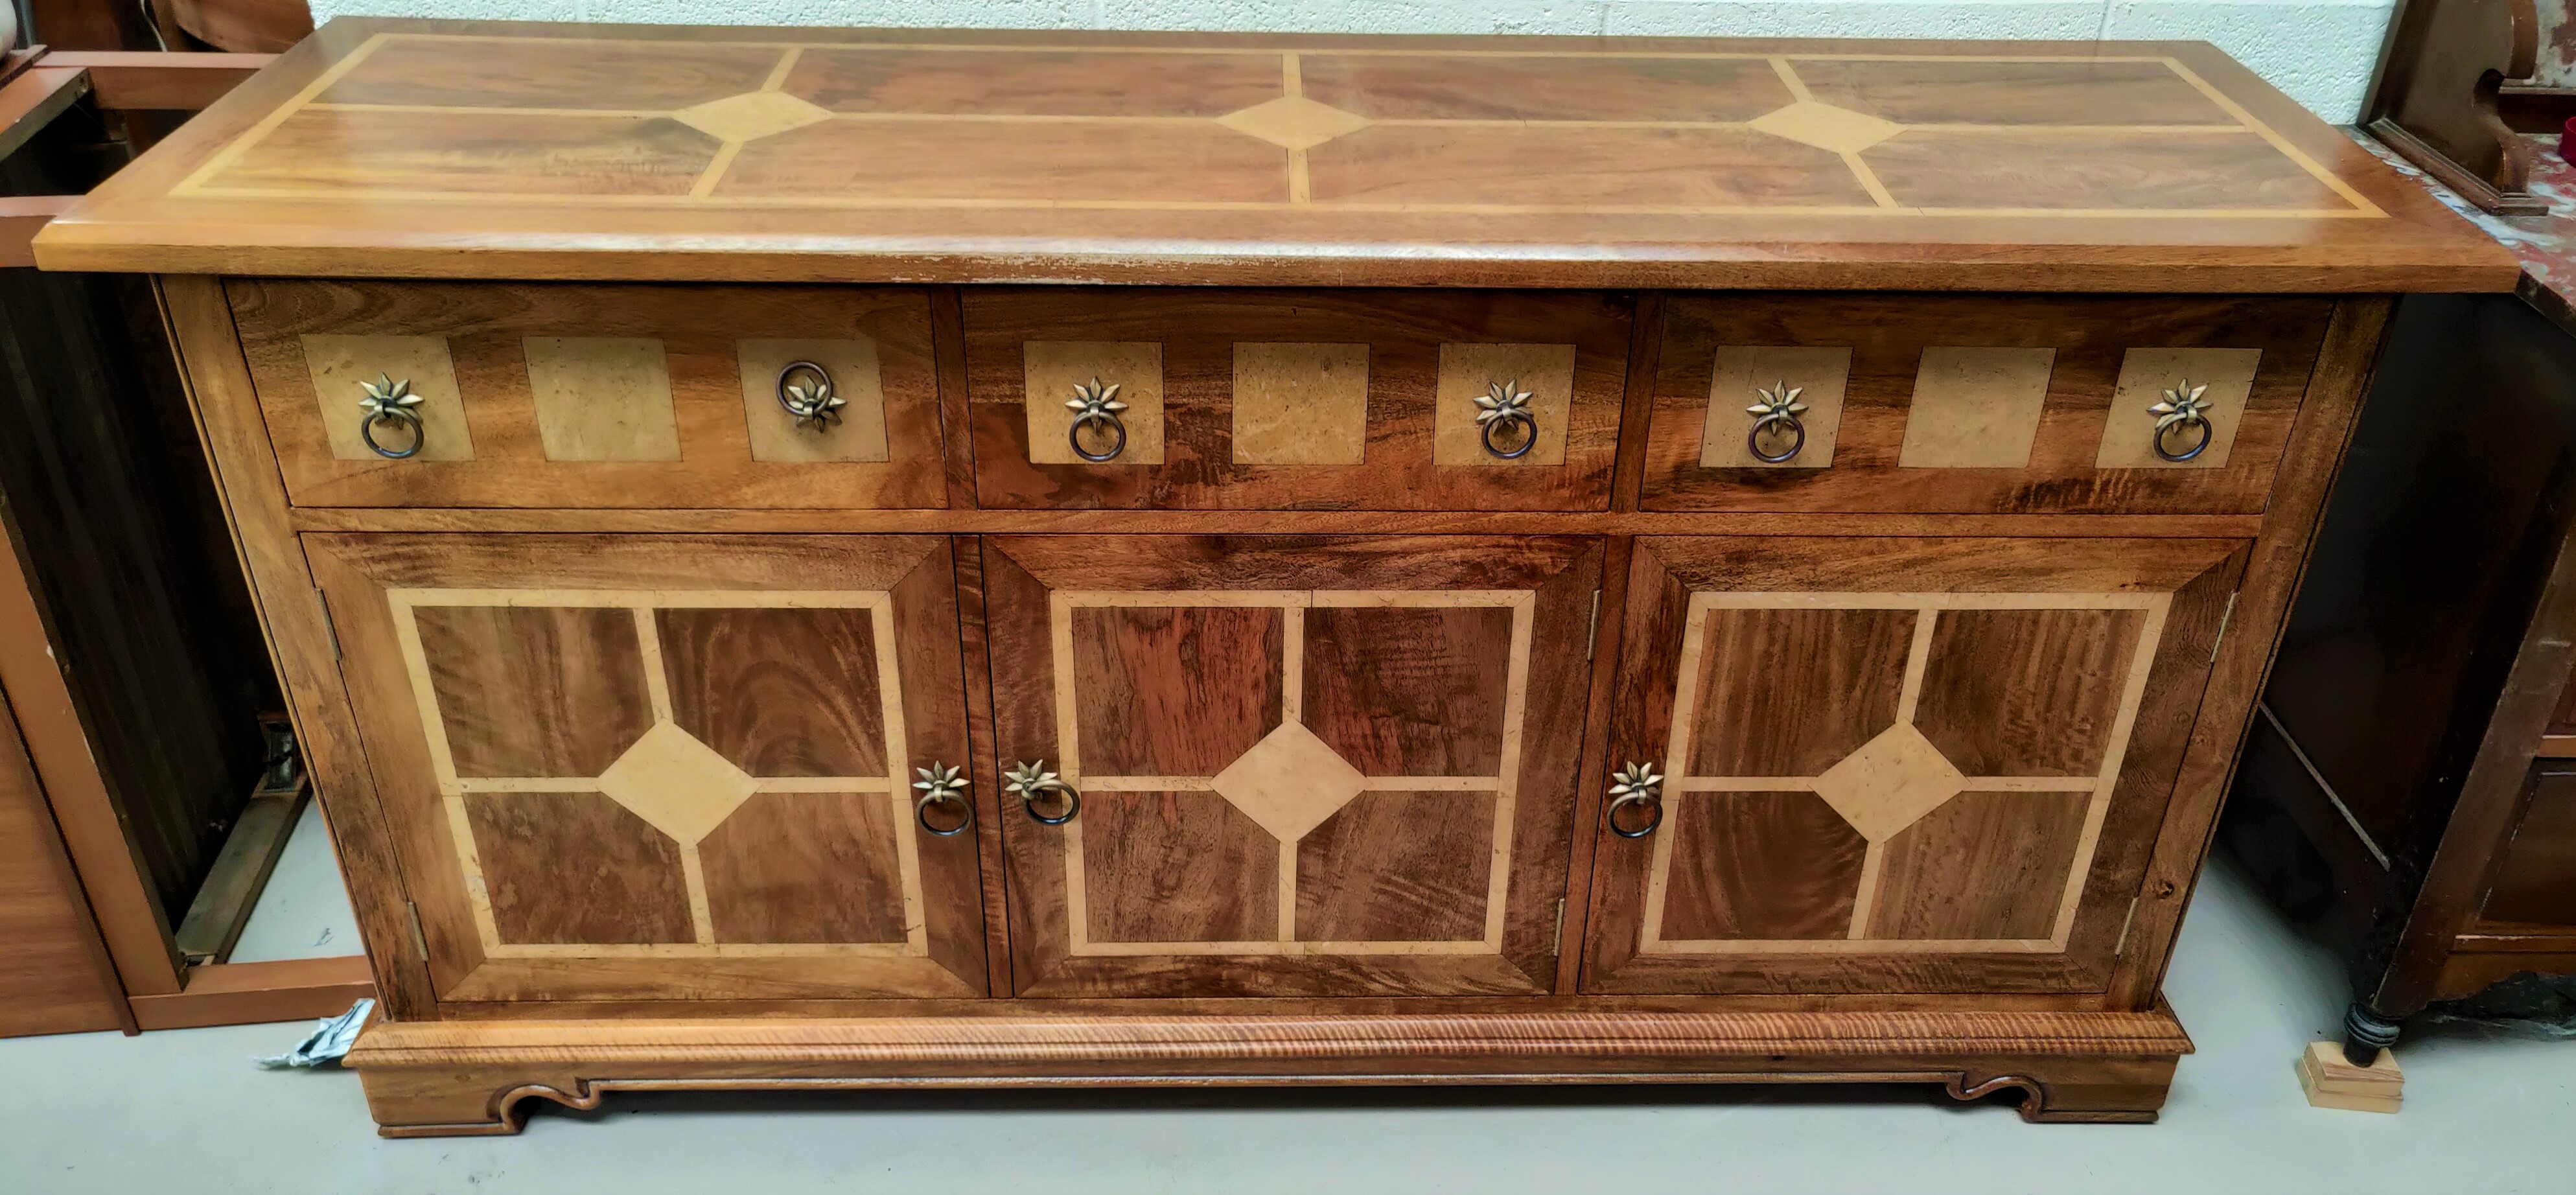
{"left": 984, "top": 536, "right": 1599, "bottom": 997}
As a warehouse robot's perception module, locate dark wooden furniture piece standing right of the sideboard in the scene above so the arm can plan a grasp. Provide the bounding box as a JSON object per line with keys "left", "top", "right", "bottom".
{"left": 2225, "top": 270, "right": 2576, "bottom": 1063}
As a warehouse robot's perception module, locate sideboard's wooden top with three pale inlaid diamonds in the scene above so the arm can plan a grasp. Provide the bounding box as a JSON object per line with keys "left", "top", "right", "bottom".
{"left": 36, "top": 18, "right": 2517, "bottom": 291}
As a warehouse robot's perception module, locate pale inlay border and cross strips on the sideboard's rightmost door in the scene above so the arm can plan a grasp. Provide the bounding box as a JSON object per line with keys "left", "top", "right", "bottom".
{"left": 1638, "top": 590, "right": 2174, "bottom": 955}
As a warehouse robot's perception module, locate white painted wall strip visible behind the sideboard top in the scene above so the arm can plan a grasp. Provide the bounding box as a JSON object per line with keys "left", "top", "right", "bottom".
{"left": 312, "top": 0, "right": 2393, "bottom": 124}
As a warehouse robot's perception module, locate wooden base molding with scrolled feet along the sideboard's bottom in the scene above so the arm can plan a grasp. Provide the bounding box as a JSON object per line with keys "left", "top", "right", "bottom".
{"left": 348, "top": 1002, "right": 2192, "bottom": 1136}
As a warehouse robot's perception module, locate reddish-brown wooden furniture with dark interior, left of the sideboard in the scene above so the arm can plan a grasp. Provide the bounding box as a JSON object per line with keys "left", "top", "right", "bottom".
{"left": 0, "top": 44, "right": 371, "bottom": 1033}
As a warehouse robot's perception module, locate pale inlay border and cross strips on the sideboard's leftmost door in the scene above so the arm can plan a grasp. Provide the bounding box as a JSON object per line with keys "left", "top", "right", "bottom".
{"left": 384, "top": 587, "right": 930, "bottom": 958}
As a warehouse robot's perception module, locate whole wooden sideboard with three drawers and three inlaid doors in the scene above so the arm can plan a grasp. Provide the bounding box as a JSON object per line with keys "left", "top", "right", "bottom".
{"left": 36, "top": 21, "right": 2514, "bottom": 1133}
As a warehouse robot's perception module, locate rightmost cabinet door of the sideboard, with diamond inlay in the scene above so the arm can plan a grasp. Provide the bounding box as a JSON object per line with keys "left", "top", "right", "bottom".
{"left": 1584, "top": 539, "right": 2244, "bottom": 994}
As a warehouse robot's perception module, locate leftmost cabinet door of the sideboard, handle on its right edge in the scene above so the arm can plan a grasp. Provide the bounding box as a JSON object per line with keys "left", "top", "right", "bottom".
{"left": 304, "top": 536, "right": 984, "bottom": 999}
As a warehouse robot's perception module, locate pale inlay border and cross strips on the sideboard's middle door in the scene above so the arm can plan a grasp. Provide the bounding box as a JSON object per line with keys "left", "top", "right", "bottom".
{"left": 1049, "top": 590, "right": 1538, "bottom": 958}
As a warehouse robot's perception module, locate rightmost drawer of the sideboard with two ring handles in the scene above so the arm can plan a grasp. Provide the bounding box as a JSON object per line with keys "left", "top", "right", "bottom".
{"left": 1641, "top": 294, "right": 2334, "bottom": 515}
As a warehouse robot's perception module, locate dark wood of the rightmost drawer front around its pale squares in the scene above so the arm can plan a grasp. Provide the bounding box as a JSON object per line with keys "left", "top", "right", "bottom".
{"left": 1641, "top": 294, "right": 2331, "bottom": 513}
